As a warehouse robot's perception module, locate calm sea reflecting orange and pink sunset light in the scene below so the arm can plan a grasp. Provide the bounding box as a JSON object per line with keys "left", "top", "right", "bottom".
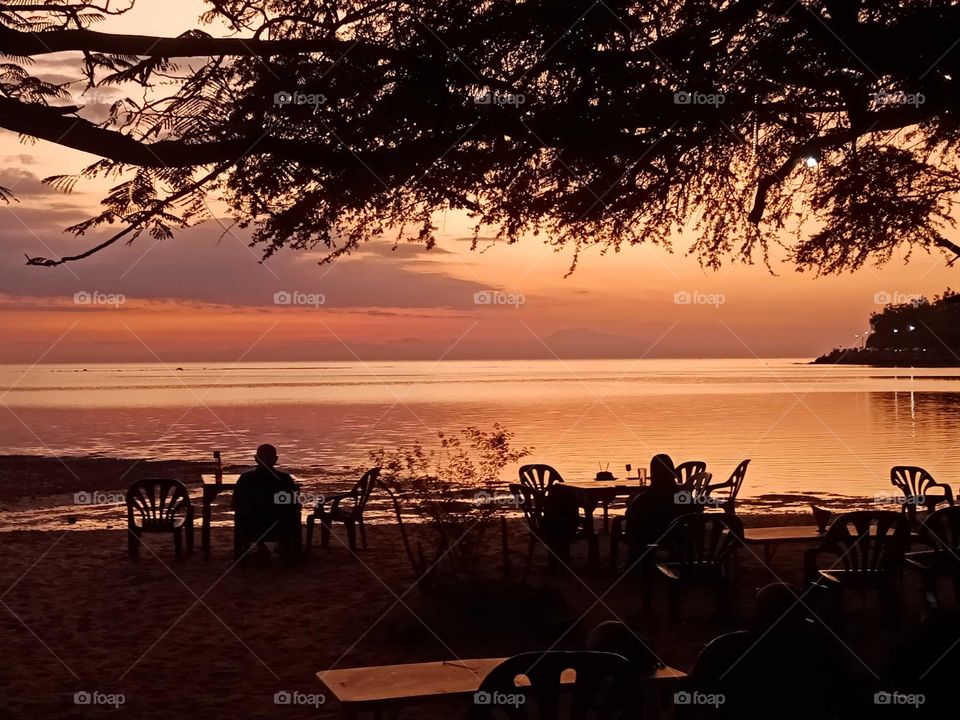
{"left": 0, "top": 359, "right": 960, "bottom": 504}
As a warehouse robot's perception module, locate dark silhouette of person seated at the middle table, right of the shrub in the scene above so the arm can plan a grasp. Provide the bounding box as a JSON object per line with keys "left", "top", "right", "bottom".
{"left": 624, "top": 454, "right": 695, "bottom": 566}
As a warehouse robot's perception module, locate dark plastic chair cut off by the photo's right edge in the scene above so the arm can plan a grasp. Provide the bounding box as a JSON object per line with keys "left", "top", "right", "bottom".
{"left": 905, "top": 507, "right": 960, "bottom": 610}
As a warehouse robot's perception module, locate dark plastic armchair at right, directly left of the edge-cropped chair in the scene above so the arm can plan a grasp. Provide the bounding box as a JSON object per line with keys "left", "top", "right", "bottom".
{"left": 804, "top": 510, "right": 910, "bottom": 617}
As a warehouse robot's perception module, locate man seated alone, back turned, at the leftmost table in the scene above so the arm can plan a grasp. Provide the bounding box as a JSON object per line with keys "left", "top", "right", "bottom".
{"left": 233, "top": 445, "right": 301, "bottom": 562}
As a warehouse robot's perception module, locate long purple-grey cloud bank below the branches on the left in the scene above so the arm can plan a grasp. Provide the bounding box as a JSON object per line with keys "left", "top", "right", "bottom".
{"left": 0, "top": 218, "right": 520, "bottom": 311}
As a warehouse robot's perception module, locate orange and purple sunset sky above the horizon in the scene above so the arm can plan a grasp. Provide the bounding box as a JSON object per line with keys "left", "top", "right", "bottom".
{"left": 0, "top": 0, "right": 956, "bottom": 363}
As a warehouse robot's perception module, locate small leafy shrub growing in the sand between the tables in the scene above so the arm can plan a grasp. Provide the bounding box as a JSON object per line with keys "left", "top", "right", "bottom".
{"left": 370, "top": 423, "right": 531, "bottom": 589}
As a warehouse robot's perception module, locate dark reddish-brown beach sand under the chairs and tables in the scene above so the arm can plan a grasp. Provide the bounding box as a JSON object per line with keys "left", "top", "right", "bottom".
{"left": 0, "top": 458, "right": 920, "bottom": 720}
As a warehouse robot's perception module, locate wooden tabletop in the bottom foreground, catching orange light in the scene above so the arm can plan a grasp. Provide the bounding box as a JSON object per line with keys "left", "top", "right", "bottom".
{"left": 317, "top": 658, "right": 687, "bottom": 718}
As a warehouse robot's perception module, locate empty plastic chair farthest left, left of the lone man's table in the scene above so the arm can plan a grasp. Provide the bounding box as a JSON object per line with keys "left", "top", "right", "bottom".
{"left": 127, "top": 479, "right": 193, "bottom": 560}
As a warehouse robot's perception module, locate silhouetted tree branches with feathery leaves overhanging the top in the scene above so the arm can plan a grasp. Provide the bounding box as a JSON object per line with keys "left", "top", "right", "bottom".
{"left": 0, "top": 0, "right": 960, "bottom": 272}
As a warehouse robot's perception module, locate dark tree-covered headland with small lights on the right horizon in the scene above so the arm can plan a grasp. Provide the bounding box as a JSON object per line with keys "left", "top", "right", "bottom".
{"left": 814, "top": 288, "right": 960, "bottom": 367}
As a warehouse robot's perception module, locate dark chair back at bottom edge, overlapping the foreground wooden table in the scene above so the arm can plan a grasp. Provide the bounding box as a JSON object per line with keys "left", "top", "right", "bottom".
{"left": 466, "top": 651, "right": 640, "bottom": 720}
